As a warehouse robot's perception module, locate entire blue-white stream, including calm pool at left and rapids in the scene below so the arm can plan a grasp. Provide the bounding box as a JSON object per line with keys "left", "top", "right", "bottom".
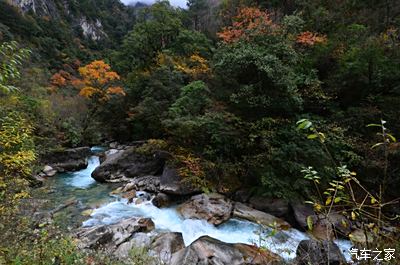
{"left": 34, "top": 148, "right": 351, "bottom": 259}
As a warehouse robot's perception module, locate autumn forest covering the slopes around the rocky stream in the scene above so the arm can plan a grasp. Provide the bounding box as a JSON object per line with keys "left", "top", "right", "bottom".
{"left": 0, "top": 0, "right": 400, "bottom": 265}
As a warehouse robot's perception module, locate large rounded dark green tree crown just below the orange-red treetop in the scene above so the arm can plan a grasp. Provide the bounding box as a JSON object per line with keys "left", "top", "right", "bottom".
{"left": 214, "top": 38, "right": 302, "bottom": 117}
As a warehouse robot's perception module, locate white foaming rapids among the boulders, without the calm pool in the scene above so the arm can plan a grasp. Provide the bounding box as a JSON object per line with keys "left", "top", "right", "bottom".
{"left": 66, "top": 151, "right": 351, "bottom": 260}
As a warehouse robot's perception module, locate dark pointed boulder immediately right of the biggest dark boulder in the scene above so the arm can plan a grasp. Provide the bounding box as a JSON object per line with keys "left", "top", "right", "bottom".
{"left": 160, "top": 166, "right": 200, "bottom": 196}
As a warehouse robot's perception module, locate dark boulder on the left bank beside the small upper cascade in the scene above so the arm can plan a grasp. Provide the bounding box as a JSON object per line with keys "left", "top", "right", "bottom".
{"left": 41, "top": 147, "right": 91, "bottom": 172}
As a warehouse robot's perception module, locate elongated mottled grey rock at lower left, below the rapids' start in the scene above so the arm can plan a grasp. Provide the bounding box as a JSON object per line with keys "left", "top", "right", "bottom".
{"left": 76, "top": 217, "right": 154, "bottom": 250}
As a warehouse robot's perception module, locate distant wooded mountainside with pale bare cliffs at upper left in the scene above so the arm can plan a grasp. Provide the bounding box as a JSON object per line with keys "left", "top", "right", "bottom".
{"left": 0, "top": 0, "right": 135, "bottom": 67}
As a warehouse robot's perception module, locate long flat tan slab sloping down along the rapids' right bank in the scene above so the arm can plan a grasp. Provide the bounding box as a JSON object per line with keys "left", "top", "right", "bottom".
{"left": 233, "top": 202, "right": 290, "bottom": 230}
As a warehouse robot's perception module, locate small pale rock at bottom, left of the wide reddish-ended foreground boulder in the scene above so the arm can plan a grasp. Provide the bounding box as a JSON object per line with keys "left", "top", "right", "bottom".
{"left": 149, "top": 232, "right": 185, "bottom": 264}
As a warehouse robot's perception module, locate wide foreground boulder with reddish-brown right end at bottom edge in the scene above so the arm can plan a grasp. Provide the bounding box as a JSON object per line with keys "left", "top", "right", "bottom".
{"left": 169, "top": 236, "right": 283, "bottom": 265}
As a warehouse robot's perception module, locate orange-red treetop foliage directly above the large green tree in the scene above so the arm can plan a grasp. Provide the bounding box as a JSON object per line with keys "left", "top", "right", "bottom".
{"left": 217, "top": 7, "right": 277, "bottom": 43}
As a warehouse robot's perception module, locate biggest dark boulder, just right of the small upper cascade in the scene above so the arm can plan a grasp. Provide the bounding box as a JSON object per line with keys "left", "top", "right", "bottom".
{"left": 92, "top": 147, "right": 164, "bottom": 182}
